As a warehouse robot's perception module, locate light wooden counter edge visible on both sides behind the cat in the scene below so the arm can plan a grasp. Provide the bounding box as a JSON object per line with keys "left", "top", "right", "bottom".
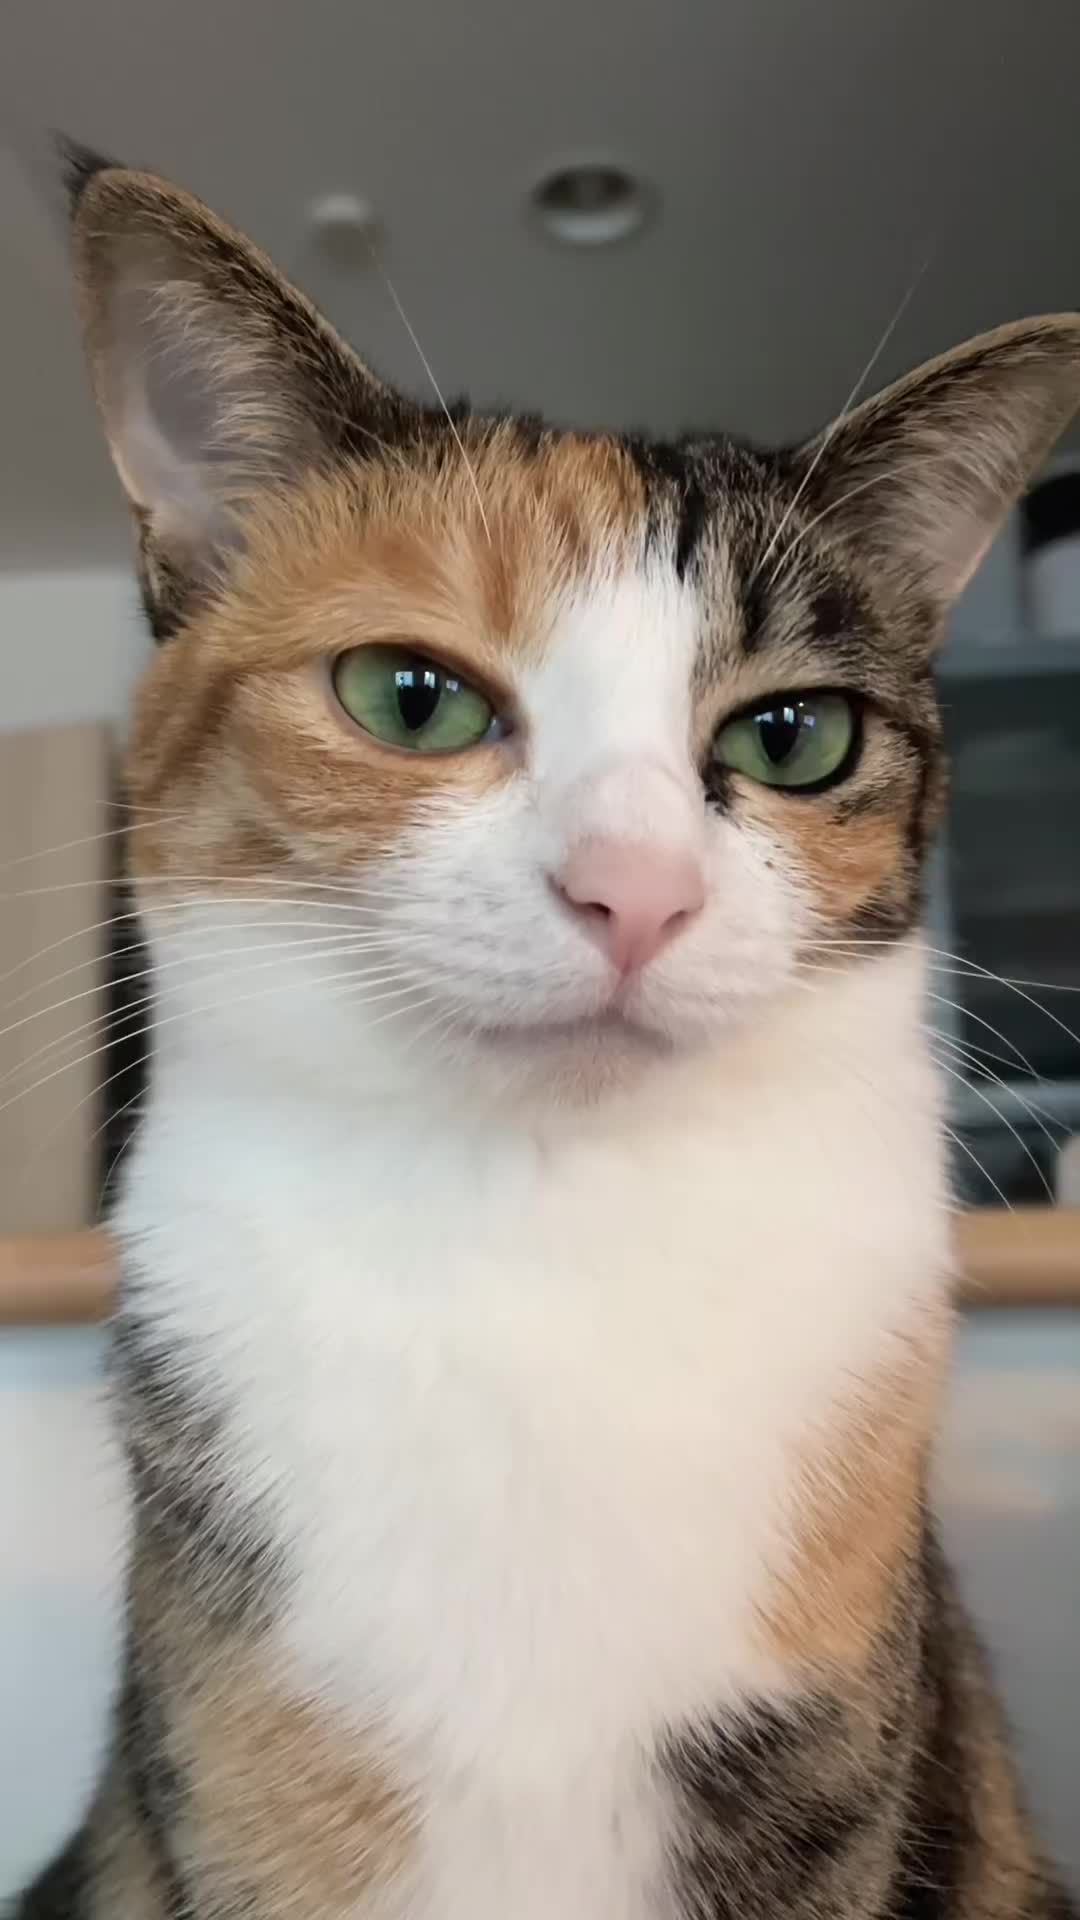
{"left": 0, "top": 1208, "right": 1080, "bottom": 1327}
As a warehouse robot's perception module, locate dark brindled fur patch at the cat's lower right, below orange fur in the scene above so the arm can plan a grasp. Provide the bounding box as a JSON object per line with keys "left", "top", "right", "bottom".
{"left": 665, "top": 1523, "right": 1072, "bottom": 1920}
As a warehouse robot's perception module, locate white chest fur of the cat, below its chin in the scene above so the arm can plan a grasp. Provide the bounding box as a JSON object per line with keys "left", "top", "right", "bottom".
{"left": 121, "top": 952, "right": 944, "bottom": 1920}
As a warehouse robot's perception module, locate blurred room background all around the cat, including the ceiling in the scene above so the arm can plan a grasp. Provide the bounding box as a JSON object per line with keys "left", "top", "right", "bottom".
{"left": 0, "top": 0, "right": 1080, "bottom": 1897}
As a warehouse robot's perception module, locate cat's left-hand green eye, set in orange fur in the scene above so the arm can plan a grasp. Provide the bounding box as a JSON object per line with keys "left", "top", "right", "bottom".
{"left": 334, "top": 647, "right": 498, "bottom": 753}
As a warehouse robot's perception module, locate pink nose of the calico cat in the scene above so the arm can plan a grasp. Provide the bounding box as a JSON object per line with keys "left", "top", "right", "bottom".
{"left": 555, "top": 839, "right": 705, "bottom": 973}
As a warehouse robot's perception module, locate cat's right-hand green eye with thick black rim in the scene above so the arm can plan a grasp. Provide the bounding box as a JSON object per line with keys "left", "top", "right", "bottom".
{"left": 713, "top": 693, "right": 857, "bottom": 787}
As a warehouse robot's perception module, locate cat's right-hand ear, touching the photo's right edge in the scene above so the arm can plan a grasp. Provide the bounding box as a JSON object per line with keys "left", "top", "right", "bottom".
{"left": 796, "top": 315, "right": 1080, "bottom": 616}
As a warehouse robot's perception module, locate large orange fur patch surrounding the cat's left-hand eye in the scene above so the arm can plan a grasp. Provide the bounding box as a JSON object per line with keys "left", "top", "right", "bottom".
{"left": 129, "top": 428, "right": 644, "bottom": 885}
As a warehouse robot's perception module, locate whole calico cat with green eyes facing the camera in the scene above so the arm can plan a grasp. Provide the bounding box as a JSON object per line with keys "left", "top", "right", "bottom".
{"left": 19, "top": 157, "right": 1080, "bottom": 1920}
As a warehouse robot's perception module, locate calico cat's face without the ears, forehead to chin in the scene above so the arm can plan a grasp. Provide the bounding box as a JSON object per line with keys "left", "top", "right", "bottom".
{"left": 113, "top": 428, "right": 938, "bottom": 1082}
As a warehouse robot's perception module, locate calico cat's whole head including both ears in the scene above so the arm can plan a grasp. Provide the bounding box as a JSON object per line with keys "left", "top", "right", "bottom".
{"left": 65, "top": 157, "right": 1080, "bottom": 1085}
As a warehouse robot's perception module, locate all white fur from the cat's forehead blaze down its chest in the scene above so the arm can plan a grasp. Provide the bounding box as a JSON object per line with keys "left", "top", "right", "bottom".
{"left": 119, "top": 576, "right": 945, "bottom": 1920}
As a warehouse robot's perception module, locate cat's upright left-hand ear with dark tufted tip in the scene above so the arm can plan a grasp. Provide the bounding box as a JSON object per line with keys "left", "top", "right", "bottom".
{"left": 65, "top": 148, "right": 413, "bottom": 636}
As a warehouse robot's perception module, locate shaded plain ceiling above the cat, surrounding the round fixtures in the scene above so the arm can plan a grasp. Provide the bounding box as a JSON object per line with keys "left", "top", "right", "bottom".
{"left": 0, "top": 0, "right": 1080, "bottom": 566}
